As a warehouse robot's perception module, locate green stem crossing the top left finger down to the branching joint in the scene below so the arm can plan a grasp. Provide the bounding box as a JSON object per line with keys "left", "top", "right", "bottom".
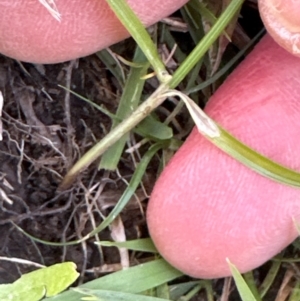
{"left": 106, "top": 0, "right": 170, "bottom": 83}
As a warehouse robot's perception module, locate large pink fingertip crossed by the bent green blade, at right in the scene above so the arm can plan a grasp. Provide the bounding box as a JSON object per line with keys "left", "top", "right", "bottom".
{"left": 147, "top": 36, "right": 300, "bottom": 278}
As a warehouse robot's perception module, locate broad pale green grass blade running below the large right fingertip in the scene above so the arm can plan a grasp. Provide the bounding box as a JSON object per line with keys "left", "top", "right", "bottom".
{"left": 47, "top": 259, "right": 182, "bottom": 301}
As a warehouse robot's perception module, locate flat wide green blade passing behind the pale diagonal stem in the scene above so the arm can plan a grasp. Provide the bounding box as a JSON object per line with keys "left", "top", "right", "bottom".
{"left": 99, "top": 47, "right": 149, "bottom": 170}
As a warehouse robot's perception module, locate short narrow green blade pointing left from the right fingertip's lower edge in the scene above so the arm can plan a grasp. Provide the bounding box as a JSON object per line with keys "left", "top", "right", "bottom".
{"left": 95, "top": 238, "right": 157, "bottom": 253}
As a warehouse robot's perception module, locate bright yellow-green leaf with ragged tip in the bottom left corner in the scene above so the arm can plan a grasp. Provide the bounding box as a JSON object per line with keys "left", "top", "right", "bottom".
{"left": 0, "top": 262, "right": 79, "bottom": 301}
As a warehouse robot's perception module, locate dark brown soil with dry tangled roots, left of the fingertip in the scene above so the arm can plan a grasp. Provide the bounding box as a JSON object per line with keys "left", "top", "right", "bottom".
{"left": 0, "top": 51, "right": 150, "bottom": 283}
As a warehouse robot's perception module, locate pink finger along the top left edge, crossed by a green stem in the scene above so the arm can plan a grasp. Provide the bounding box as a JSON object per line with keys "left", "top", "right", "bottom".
{"left": 0, "top": 0, "right": 187, "bottom": 63}
